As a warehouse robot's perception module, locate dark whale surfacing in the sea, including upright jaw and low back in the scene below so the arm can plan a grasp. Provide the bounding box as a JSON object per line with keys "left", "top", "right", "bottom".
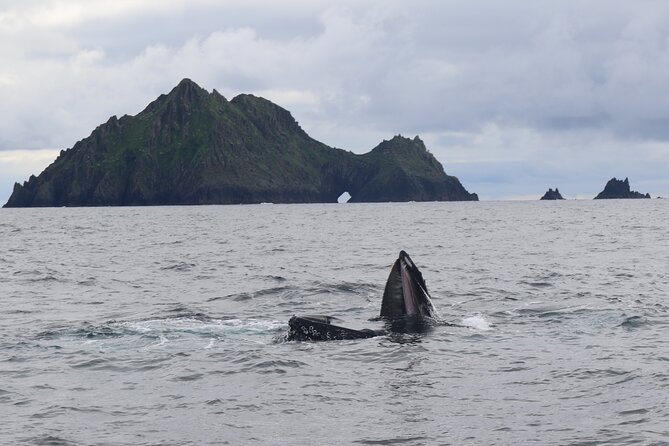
{"left": 286, "top": 251, "right": 439, "bottom": 341}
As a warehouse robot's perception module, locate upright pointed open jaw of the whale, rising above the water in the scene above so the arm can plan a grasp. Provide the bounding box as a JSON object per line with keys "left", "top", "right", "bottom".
{"left": 380, "top": 251, "right": 438, "bottom": 320}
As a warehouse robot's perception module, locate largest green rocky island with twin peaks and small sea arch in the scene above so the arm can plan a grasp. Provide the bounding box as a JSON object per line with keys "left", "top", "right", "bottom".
{"left": 5, "top": 79, "right": 478, "bottom": 207}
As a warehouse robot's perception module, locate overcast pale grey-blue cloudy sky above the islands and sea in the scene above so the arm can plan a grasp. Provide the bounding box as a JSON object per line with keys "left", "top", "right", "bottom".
{"left": 0, "top": 0, "right": 669, "bottom": 203}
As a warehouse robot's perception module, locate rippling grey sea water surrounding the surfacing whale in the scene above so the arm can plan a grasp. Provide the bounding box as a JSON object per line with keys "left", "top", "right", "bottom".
{"left": 0, "top": 200, "right": 669, "bottom": 445}
